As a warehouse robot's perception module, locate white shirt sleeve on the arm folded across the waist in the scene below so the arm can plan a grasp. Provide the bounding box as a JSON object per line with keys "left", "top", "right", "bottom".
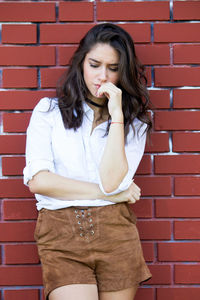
{"left": 23, "top": 98, "right": 55, "bottom": 185}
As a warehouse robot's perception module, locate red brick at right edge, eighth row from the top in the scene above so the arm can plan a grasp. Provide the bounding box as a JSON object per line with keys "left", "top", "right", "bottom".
{"left": 154, "top": 155, "right": 200, "bottom": 174}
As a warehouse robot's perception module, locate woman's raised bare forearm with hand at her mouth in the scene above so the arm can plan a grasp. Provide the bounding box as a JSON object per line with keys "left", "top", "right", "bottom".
{"left": 98, "top": 83, "right": 128, "bottom": 193}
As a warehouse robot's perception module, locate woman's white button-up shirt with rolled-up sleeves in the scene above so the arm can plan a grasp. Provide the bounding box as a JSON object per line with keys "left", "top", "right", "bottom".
{"left": 24, "top": 98, "right": 146, "bottom": 210}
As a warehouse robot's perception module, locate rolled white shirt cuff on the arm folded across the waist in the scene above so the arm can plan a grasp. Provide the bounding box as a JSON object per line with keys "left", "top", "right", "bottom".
{"left": 23, "top": 159, "right": 55, "bottom": 186}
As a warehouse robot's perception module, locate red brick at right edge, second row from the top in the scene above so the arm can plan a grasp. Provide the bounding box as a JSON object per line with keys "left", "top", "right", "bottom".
{"left": 154, "top": 23, "right": 200, "bottom": 43}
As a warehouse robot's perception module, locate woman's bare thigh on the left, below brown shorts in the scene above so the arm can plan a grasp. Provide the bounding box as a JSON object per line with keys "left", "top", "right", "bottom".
{"left": 49, "top": 284, "right": 98, "bottom": 300}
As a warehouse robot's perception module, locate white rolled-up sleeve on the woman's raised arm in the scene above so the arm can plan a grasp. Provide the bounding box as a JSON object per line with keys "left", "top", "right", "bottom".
{"left": 99, "top": 121, "right": 147, "bottom": 196}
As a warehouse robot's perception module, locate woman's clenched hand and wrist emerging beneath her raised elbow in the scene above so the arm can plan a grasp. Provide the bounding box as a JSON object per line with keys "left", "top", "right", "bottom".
{"left": 107, "top": 182, "right": 141, "bottom": 204}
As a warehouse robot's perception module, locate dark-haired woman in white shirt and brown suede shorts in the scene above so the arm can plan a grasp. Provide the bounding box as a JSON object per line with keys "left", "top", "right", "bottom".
{"left": 24, "top": 23, "right": 151, "bottom": 300}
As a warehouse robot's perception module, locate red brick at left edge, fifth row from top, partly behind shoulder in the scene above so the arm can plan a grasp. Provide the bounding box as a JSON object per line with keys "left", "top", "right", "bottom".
{"left": 0, "top": 90, "right": 55, "bottom": 110}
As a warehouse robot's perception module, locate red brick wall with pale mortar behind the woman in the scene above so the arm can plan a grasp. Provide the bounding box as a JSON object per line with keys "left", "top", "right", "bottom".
{"left": 0, "top": 1, "right": 200, "bottom": 300}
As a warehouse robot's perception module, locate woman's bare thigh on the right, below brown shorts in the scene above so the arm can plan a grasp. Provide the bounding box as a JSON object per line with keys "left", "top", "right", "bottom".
{"left": 99, "top": 285, "right": 138, "bottom": 300}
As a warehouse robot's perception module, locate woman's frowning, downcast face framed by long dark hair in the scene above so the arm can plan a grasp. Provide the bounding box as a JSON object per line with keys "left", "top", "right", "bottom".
{"left": 83, "top": 43, "right": 119, "bottom": 99}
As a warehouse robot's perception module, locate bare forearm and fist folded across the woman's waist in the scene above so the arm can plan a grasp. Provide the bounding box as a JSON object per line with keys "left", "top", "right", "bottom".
{"left": 28, "top": 171, "right": 140, "bottom": 203}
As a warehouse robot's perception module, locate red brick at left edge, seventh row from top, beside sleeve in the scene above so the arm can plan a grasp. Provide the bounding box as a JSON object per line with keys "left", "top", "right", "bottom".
{"left": 0, "top": 135, "right": 26, "bottom": 154}
